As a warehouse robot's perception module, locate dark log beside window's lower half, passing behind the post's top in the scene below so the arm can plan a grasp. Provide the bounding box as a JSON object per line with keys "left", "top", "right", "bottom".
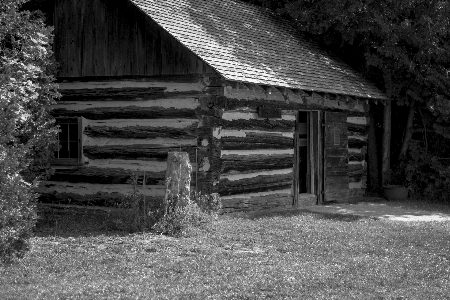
{"left": 83, "top": 145, "right": 196, "bottom": 162}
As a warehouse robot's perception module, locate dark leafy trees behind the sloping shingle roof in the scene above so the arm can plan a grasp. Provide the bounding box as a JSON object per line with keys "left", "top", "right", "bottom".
{"left": 244, "top": 0, "right": 450, "bottom": 188}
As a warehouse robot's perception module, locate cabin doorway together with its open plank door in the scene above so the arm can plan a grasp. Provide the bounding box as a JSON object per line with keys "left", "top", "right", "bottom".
{"left": 293, "top": 111, "right": 349, "bottom": 206}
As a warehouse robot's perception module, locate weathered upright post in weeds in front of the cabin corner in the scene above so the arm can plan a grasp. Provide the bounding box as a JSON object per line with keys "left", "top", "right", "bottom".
{"left": 164, "top": 152, "right": 192, "bottom": 214}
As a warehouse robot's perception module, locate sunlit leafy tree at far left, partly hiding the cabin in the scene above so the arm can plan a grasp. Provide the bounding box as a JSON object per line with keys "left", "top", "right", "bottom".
{"left": 0, "top": 0, "right": 59, "bottom": 260}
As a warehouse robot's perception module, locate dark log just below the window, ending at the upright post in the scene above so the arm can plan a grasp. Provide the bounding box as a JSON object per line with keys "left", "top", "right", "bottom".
{"left": 48, "top": 167, "right": 165, "bottom": 186}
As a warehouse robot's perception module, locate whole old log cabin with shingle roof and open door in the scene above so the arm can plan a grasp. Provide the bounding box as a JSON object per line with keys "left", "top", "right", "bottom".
{"left": 32, "top": 0, "right": 390, "bottom": 213}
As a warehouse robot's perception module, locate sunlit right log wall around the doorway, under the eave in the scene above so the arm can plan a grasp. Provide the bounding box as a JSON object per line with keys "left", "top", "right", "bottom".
{"left": 211, "top": 82, "right": 368, "bottom": 212}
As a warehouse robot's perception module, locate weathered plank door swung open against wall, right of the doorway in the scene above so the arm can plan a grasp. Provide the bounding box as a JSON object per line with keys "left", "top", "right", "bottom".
{"left": 323, "top": 112, "right": 348, "bottom": 202}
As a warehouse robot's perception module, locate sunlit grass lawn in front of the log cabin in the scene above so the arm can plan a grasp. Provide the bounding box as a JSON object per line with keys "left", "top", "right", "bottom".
{"left": 0, "top": 207, "right": 450, "bottom": 300}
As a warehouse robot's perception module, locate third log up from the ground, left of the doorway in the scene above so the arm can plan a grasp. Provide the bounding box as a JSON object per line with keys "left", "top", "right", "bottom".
{"left": 221, "top": 155, "right": 294, "bottom": 173}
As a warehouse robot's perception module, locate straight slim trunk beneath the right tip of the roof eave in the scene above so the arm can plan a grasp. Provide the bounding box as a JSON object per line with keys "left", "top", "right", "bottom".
{"left": 381, "top": 100, "right": 392, "bottom": 185}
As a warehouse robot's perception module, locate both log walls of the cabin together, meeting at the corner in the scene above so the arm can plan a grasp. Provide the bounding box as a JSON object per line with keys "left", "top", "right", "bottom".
{"left": 39, "top": 76, "right": 368, "bottom": 212}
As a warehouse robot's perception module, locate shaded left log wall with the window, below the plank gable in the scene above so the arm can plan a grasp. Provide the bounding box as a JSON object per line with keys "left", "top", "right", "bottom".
{"left": 38, "top": 76, "right": 219, "bottom": 206}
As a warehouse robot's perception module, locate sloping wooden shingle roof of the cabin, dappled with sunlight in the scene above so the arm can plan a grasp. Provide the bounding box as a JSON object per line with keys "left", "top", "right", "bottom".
{"left": 130, "top": 0, "right": 387, "bottom": 99}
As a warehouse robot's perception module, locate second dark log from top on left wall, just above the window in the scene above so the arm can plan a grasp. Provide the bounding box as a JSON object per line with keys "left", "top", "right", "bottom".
{"left": 51, "top": 106, "right": 197, "bottom": 120}
